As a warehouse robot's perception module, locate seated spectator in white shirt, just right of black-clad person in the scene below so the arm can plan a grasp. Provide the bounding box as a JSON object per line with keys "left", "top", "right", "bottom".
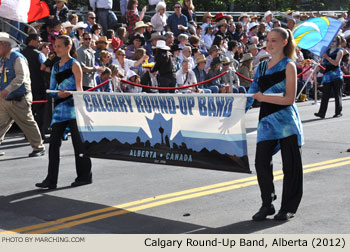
{"left": 176, "top": 59, "right": 197, "bottom": 93}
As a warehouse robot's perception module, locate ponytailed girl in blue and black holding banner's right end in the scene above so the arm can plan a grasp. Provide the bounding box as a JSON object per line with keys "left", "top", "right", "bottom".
{"left": 247, "top": 28, "right": 303, "bottom": 221}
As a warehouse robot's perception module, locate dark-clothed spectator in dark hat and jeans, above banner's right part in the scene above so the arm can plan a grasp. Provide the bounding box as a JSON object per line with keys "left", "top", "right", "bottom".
{"left": 203, "top": 56, "right": 226, "bottom": 93}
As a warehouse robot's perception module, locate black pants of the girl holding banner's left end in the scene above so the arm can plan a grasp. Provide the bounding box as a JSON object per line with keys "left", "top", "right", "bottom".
{"left": 45, "top": 120, "right": 92, "bottom": 184}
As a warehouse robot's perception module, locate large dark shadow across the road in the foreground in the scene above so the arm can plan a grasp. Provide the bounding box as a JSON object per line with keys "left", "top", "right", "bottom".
{"left": 0, "top": 187, "right": 281, "bottom": 234}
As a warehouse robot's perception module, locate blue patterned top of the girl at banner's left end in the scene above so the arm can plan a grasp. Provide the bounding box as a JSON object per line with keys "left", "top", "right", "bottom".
{"left": 50, "top": 58, "right": 78, "bottom": 125}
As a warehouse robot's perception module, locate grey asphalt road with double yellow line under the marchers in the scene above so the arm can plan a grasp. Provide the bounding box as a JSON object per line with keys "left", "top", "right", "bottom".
{"left": 0, "top": 98, "right": 350, "bottom": 234}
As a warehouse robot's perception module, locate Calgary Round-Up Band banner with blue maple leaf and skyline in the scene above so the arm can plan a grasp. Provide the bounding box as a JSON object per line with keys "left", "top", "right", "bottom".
{"left": 73, "top": 92, "right": 250, "bottom": 173}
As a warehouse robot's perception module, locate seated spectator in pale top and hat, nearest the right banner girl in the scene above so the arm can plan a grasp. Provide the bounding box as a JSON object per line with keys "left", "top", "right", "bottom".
{"left": 221, "top": 57, "right": 243, "bottom": 93}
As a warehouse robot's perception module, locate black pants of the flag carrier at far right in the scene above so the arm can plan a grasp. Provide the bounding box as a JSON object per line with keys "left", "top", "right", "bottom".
{"left": 318, "top": 79, "right": 343, "bottom": 116}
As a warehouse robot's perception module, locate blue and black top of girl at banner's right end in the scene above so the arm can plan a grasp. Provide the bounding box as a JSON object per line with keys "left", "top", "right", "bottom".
{"left": 246, "top": 57, "right": 304, "bottom": 153}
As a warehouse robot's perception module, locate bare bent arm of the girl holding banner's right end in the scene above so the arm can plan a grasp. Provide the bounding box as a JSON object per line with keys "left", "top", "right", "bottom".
{"left": 253, "top": 62, "right": 297, "bottom": 105}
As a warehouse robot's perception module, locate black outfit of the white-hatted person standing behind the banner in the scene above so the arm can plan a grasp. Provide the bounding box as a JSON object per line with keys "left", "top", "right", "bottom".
{"left": 151, "top": 51, "right": 176, "bottom": 93}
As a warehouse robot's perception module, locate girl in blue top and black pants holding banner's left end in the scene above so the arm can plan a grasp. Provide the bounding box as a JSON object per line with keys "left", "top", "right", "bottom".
{"left": 35, "top": 35, "right": 92, "bottom": 189}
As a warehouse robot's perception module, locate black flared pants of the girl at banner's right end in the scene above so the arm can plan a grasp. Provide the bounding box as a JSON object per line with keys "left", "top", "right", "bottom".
{"left": 255, "top": 135, "right": 303, "bottom": 213}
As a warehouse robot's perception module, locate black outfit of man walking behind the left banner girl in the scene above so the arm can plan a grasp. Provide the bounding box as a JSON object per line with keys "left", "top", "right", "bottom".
{"left": 22, "top": 46, "right": 51, "bottom": 140}
